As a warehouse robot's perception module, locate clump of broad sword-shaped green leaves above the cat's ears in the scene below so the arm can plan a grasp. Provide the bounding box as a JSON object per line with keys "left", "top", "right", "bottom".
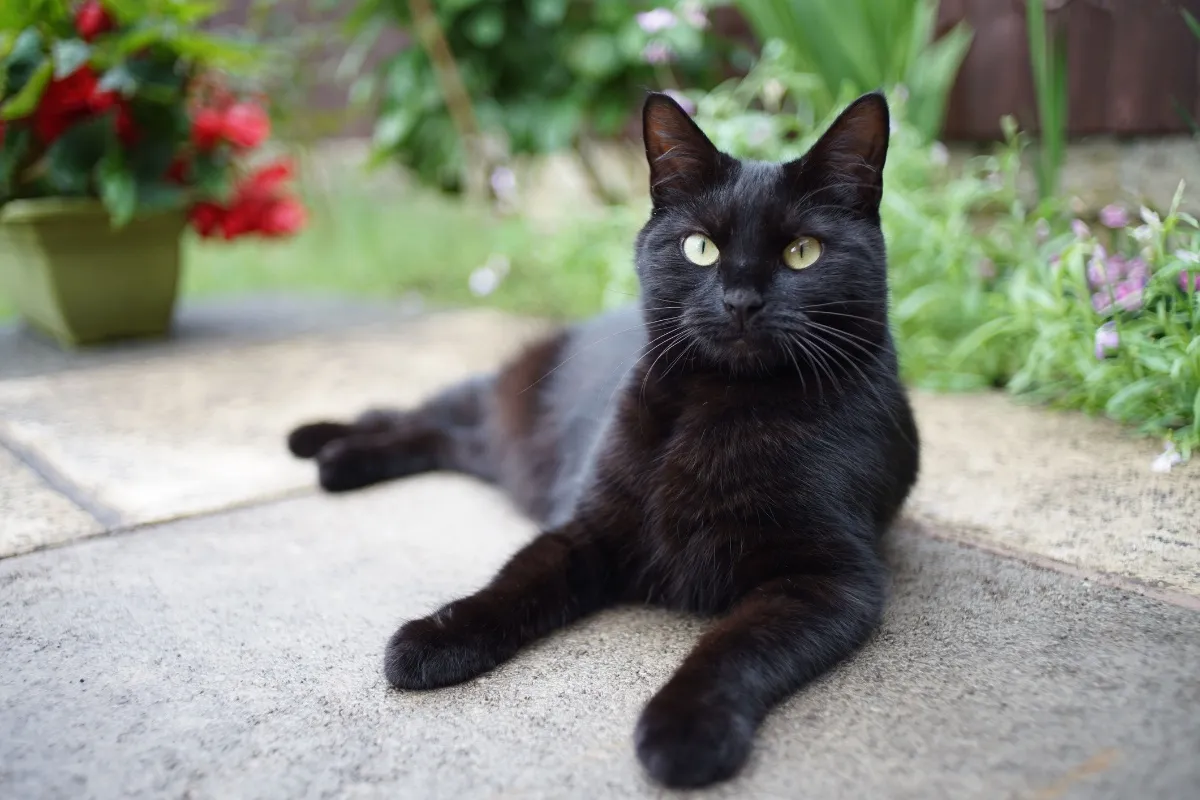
{"left": 737, "top": 0, "right": 972, "bottom": 139}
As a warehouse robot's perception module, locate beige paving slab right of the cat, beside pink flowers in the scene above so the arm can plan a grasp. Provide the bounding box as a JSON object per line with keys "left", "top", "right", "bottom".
{"left": 910, "top": 392, "right": 1200, "bottom": 597}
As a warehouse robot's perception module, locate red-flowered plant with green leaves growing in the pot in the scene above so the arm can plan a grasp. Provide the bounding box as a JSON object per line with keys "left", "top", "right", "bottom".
{"left": 0, "top": 0, "right": 305, "bottom": 239}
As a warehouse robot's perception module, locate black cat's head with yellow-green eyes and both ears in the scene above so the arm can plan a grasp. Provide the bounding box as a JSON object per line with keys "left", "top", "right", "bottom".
{"left": 637, "top": 94, "right": 889, "bottom": 374}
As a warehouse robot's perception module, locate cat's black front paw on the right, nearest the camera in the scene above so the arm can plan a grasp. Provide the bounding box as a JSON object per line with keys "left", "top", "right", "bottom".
{"left": 634, "top": 688, "right": 755, "bottom": 788}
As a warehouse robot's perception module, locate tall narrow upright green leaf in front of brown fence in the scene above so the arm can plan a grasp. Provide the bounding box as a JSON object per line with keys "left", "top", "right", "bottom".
{"left": 1025, "top": 0, "right": 1070, "bottom": 199}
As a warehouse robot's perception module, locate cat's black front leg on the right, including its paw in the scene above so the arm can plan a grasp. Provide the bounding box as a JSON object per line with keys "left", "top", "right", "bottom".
{"left": 635, "top": 544, "right": 884, "bottom": 787}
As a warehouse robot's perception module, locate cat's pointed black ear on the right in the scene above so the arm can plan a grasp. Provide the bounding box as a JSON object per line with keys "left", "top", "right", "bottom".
{"left": 787, "top": 92, "right": 890, "bottom": 216}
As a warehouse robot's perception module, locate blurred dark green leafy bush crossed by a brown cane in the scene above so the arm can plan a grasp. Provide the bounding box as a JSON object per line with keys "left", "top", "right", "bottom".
{"left": 342, "top": 0, "right": 733, "bottom": 190}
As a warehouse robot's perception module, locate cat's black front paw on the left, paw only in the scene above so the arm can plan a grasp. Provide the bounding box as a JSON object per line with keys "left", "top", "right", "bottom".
{"left": 383, "top": 612, "right": 498, "bottom": 688}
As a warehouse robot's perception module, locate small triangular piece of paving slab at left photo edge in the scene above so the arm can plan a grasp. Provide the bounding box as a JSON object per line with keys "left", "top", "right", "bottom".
{"left": 0, "top": 445, "right": 103, "bottom": 558}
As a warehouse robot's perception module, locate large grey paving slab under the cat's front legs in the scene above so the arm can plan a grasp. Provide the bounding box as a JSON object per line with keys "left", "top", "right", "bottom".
{"left": 0, "top": 475, "right": 1200, "bottom": 800}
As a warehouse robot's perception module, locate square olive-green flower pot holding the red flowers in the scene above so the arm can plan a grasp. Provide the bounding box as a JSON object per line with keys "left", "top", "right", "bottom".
{"left": 0, "top": 198, "right": 186, "bottom": 348}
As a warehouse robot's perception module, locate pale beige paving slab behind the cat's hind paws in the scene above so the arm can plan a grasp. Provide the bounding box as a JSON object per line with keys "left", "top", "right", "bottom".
{"left": 0, "top": 312, "right": 549, "bottom": 534}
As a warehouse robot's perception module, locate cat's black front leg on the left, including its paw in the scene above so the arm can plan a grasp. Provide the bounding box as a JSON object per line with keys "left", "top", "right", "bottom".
{"left": 384, "top": 522, "right": 620, "bottom": 688}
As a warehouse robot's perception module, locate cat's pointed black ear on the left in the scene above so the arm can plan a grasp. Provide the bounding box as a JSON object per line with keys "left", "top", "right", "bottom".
{"left": 642, "top": 94, "right": 728, "bottom": 206}
